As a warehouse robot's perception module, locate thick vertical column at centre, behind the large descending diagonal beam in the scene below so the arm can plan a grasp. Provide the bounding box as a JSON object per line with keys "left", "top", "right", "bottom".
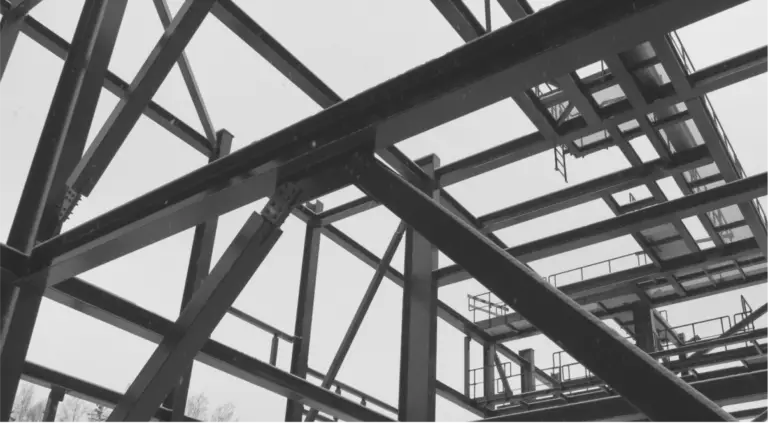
{"left": 398, "top": 155, "right": 440, "bottom": 423}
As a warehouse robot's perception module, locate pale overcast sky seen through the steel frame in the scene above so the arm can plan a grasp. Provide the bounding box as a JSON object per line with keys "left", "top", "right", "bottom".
{"left": 0, "top": 0, "right": 768, "bottom": 422}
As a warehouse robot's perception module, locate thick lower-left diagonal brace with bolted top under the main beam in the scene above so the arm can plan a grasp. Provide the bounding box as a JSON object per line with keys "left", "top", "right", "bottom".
{"left": 107, "top": 186, "right": 299, "bottom": 423}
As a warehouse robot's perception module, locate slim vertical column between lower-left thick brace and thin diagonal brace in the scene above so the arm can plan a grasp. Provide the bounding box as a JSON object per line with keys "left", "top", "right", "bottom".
{"left": 285, "top": 202, "right": 323, "bottom": 423}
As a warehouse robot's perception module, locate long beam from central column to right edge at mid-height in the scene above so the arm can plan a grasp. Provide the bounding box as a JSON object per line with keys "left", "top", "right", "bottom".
{"left": 438, "top": 168, "right": 768, "bottom": 283}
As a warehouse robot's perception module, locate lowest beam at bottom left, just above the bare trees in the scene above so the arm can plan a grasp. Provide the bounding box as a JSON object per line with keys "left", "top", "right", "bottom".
{"left": 22, "top": 361, "right": 201, "bottom": 423}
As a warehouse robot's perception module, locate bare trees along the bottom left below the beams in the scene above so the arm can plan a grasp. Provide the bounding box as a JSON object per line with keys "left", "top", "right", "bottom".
{"left": 10, "top": 382, "right": 239, "bottom": 423}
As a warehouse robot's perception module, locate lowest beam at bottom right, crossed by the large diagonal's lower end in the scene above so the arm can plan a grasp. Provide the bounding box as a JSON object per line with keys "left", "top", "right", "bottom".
{"left": 476, "top": 370, "right": 768, "bottom": 423}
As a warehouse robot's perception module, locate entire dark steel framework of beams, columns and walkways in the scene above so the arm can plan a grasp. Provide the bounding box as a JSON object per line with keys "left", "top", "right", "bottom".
{"left": 0, "top": 0, "right": 768, "bottom": 423}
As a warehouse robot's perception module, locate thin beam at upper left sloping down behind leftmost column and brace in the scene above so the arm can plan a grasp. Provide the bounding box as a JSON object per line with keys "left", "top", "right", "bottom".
{"left": 0, "top": 2, "right": 213, "bottom": 156}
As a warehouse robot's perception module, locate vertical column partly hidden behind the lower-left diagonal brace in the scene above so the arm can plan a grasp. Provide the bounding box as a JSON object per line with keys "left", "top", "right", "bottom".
{"left": 163, "top": 130, "right": 233, "bottom": 423}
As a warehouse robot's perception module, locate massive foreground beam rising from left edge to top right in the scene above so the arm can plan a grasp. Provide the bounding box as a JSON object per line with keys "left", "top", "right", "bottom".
{"left": 24, "top": 0, "right": 743, "bottom": 290}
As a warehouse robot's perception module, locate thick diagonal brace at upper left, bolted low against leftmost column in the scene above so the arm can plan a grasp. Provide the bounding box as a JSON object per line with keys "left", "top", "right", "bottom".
{"left": 67, "top": 0, "right": 216, "bottom": 202}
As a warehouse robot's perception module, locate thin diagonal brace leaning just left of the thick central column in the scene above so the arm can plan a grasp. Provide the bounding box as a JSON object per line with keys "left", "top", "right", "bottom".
{"left": 304, "top": 223, "right": 405, "bottom": 423}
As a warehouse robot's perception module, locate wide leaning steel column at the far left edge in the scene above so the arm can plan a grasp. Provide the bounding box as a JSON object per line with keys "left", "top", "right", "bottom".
{"left": 0, "top": 0, "right": 127, "bottom": 421}
